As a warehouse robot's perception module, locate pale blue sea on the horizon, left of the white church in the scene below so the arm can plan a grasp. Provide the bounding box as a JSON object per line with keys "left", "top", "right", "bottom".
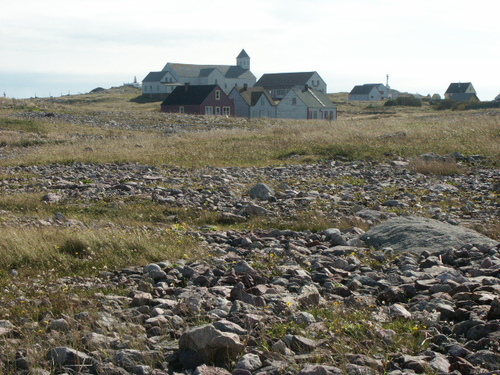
{"left": 0, "top": 71, "right": 144, "bottom": 99}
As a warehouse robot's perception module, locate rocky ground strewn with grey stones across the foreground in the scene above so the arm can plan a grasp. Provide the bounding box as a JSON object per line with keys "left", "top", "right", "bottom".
{"left": 0, "top": 160, "right": 500, "bottom": 375}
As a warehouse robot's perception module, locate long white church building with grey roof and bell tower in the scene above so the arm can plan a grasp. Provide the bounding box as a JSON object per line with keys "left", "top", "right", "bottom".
{"left": 142, "top": 49, "right": 256, "bottom": 98}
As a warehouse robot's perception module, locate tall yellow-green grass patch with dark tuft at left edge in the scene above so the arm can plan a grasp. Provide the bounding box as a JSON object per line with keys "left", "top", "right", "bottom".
{"left": 0, "top": 227, "right": 197, "bottom": 275}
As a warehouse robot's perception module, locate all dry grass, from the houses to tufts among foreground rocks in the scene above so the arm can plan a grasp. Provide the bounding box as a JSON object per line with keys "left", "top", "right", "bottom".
{"left": 0, "top": 87, "right": 500, "bottom": 372}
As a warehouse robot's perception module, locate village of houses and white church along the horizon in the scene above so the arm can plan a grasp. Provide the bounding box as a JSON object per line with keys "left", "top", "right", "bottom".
{"left": 142, "top": 49, "right": 488, "bottom": 120}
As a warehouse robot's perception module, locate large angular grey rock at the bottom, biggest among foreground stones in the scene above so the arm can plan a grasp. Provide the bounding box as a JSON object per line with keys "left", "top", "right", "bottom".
{"left": 179, "top": 324, "right": 243, "bottom": 367}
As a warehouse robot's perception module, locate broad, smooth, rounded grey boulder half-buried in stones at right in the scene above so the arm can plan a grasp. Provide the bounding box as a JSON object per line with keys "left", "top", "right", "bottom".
{"left": 360, "top": 216, "right": 497, "bottom": 254}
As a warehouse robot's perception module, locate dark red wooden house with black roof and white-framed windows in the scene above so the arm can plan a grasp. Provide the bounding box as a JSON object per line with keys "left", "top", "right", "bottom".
{"left": 161, "top": 83, "right": 234, "bottom": 116}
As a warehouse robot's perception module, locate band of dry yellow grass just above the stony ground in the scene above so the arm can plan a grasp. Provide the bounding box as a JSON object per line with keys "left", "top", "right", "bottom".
{"left": 0, "top": 108, "right": 500, "bottom": 167}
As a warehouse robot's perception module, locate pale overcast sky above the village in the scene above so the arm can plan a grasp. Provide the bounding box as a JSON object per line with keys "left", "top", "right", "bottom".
{"left": 0, "top": 0, "right": 500, "bottom": 100}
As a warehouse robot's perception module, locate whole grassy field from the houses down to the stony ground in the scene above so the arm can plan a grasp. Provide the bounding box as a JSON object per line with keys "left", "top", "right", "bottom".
{"left": 0, "top": 89, "right": 500, "bottom": 167}
